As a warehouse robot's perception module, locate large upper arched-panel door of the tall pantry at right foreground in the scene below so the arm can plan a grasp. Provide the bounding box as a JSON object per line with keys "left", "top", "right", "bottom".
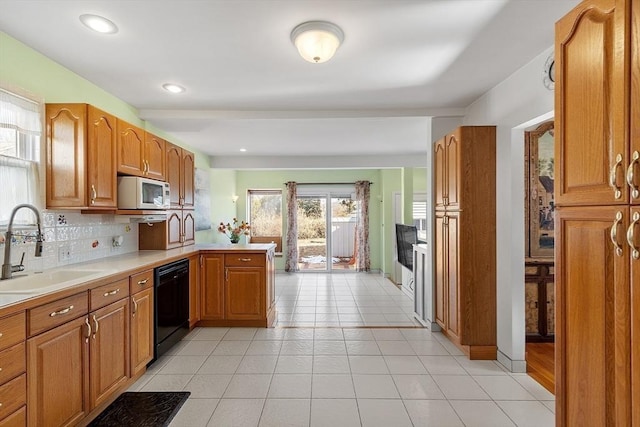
{"left": 555, "top": 0, "right": 629, "bottom": 206}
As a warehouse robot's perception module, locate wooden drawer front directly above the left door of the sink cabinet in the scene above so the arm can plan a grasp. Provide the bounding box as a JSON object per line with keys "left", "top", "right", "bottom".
{"left": 29, "top": 292, "right": 89, "bottom": 336}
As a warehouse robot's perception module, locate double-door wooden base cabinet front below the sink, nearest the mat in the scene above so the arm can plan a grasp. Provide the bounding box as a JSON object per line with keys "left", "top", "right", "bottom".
{"left": 27, "top": 298, "right": 129, "bottom": 426}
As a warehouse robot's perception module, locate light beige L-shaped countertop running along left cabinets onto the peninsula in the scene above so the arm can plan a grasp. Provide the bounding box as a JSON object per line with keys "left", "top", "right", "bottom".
{"left": 0, "top": 243, "right": 275, "bottom": 316}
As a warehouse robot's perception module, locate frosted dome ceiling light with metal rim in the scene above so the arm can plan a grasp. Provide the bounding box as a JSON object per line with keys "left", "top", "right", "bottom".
{"left": 291, "top": 21, "right": 344, "bottom": 64}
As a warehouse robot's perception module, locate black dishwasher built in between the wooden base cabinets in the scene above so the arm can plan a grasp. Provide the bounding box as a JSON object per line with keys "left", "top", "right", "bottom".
{"left": 154, "top": 259, "right": 189, "bottom": 360}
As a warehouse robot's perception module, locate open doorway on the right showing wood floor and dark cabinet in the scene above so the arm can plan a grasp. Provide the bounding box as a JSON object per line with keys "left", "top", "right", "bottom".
{"left": 524, "top": 121, "right": 555, "bottom": 393}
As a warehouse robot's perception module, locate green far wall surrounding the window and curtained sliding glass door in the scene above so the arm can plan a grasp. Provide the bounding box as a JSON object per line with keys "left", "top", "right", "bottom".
{"left": 236, "top": 169, "right": 383, "bottom": 270}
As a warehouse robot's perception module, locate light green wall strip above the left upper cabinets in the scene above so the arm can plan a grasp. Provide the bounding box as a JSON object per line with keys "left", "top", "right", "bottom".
{"left": 0, "top": 32, "right": 213, "bottom": 242}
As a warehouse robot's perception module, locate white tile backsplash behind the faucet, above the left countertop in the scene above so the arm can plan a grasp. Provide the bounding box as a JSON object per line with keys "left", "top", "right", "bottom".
{"left": 0, "top": 210, "right": 138, "bottom": 272}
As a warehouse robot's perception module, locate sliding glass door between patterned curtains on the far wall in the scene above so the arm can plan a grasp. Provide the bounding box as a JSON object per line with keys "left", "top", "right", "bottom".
{"left": 297, "top": 191, "right": 357, "bottom": 272}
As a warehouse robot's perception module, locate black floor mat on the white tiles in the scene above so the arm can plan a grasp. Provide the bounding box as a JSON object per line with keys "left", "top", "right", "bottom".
{"left": 89, "top": 391, "right": 191, "bottom": 427}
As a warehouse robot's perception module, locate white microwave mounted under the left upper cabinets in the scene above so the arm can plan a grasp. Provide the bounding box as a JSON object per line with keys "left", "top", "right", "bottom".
{"left": 118, "top": 176, "right": 171, "bottom": 209}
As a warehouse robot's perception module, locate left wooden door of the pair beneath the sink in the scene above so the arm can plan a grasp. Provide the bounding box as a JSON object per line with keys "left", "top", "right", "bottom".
{"left": 27, "top": 317, "right": 90, "bottom": 426}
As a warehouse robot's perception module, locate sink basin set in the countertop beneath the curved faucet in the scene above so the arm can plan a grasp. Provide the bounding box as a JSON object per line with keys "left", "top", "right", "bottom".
{"left": 0, "top": 268, "right": 110, "bottom": 294}
